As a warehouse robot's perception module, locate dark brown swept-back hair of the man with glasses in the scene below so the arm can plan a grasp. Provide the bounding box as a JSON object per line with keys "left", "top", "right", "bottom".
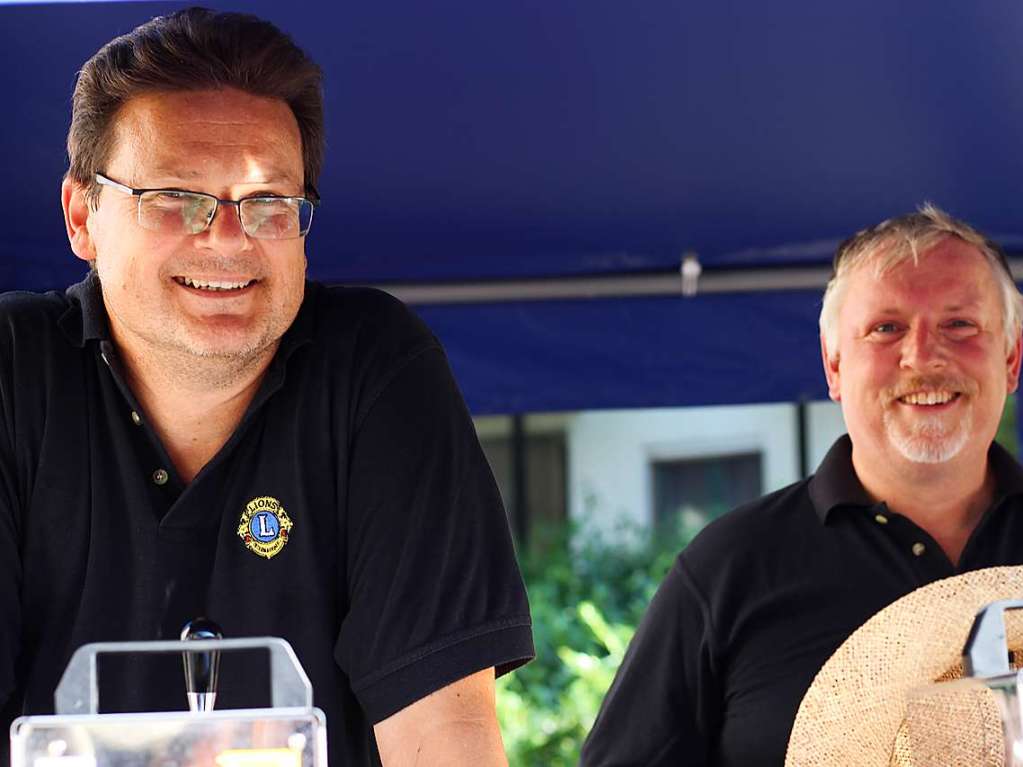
{"left": 68, "top": 8, "right": 323, "bottom": 198}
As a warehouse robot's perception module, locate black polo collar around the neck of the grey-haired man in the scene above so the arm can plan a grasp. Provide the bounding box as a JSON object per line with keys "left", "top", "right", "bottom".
{"left": 809, "top": 435, "right": 1023, "bottom": 523}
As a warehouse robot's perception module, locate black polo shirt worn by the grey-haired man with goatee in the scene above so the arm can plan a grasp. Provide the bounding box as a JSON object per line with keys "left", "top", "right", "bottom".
{"left": 581, "top": 437, "right": 1023, "bottom": 767}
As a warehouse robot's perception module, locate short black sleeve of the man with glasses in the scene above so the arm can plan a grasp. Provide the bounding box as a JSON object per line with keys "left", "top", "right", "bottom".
{"left": 336, "top": 343, "right": 533, "bottom": 722}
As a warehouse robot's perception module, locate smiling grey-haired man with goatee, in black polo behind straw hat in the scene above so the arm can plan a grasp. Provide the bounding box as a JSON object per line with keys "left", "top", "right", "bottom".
{"left": 582, "top": 206, "right": 1023, "bottom": 767}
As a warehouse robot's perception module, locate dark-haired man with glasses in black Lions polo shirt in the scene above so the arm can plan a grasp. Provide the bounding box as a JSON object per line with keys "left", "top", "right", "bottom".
{"left": 0, "top": 8, "right": 532, "bottom": 767}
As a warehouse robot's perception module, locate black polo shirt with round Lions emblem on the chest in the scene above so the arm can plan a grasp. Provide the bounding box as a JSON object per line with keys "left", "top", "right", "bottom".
{"left": 0, "top": 277, "right": 533, "bottom": 767}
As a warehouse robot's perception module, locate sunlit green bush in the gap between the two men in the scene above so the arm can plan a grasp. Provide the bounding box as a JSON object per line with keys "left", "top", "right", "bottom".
{"left": 497, "top": 519, "right": 693, "bottom": 767}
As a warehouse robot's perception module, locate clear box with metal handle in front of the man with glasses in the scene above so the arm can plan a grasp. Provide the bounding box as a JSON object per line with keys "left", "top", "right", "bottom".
{"left": 10, "top": 635, "right": 327, "bottom": 767}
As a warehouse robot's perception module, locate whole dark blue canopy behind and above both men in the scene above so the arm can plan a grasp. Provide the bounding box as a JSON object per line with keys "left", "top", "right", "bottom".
{"left": 0, "top": 0, "right": 1023, "bottom": 412}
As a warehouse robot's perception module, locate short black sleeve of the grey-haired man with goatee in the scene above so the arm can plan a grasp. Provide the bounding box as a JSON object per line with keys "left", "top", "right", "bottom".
{"left": 580, "top": 557, "right": 721, "bottom": 767}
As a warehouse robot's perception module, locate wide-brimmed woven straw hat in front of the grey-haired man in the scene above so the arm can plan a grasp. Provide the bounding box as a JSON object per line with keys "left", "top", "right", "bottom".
{"left": 785, "top": 567, "right": 1023, "bottom": 767}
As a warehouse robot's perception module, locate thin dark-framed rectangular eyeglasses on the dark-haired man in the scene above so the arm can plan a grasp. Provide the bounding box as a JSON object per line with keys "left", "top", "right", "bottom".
{"left": 96, "top": 173, "right": 319, "bottom": 239}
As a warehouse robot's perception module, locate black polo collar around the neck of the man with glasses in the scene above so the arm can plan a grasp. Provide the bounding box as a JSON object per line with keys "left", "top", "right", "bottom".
{"left": 58, "top": 271, "right": 319, "bottom": 364}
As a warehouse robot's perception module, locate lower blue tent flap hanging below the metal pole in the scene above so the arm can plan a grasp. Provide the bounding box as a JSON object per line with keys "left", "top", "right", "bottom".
{"left": 419, "top": 290, "right": 827, "bottom": 413}
